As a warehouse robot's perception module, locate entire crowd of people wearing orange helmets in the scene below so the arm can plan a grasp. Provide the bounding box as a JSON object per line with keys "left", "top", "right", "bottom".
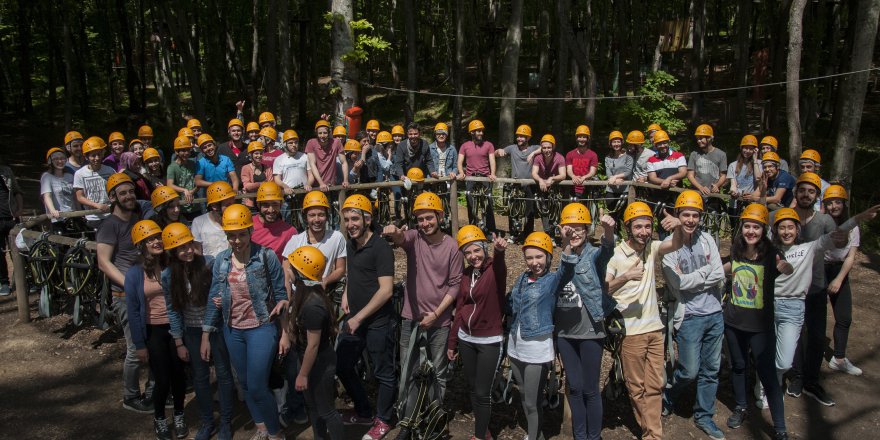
{"left": 20, "top": 113, "right": 880, "bottom": 440}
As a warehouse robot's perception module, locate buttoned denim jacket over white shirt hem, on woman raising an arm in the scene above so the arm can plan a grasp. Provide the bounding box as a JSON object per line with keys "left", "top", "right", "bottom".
{"left": 507, "top": 255, "right": 578, "bottom": 338}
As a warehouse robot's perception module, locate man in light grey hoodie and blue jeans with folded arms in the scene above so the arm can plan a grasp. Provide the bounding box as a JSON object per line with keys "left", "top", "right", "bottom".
{"left": 662, "top": 190, "right": 724, "bottom": 439}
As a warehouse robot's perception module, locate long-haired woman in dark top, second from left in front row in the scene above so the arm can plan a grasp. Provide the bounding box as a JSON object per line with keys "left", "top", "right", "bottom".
{"left": 160, "top": 223, "right": 233, "bottom": 440}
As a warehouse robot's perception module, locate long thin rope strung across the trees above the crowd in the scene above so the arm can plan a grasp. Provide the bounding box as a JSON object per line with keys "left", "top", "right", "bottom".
{"left": 357, "top": 67, "right": 880, "bottom": 101}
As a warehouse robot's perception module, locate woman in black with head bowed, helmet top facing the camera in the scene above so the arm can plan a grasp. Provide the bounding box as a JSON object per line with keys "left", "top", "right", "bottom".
{"left": 282, "top": 246, "right": 343, "bottom": 440}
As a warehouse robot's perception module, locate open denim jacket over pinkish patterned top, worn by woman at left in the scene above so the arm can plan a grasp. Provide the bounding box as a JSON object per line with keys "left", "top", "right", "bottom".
{"left": 202, "top": 243, "right": 287, "bottom": 332}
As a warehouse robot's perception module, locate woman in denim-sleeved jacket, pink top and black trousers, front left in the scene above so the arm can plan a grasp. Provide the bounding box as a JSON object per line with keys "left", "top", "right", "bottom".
{"left": 124, "top": 220, "right": 189, "bottom": 440}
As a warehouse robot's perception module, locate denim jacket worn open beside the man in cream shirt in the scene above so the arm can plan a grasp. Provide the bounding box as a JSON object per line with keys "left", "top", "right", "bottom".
{"left": 557, "top": 237, "right": 617, "bottom": 321}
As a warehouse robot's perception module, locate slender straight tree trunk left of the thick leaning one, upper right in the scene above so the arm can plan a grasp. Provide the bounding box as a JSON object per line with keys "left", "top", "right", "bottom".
{"left": 785, "top": 0, "right": 807, "bottom": 164}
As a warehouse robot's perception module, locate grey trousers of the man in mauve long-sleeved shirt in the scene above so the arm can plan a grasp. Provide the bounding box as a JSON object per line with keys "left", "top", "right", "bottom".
{"left": 400, "top": 319, "right": 449, "bottom": 413}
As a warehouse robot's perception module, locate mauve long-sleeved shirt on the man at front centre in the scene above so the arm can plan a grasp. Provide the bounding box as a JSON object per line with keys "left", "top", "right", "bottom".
{"left": 400, "top": 230, "right": 464, "bottom": 327}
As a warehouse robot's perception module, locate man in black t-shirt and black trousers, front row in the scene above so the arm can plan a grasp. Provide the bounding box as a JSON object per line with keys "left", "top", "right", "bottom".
{"left": 336, "top": 194, "right": 397, "bottom": 440}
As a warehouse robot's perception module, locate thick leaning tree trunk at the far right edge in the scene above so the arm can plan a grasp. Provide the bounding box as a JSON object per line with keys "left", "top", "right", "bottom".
{"left": 831, "top": 0, "right": 880, "bottom": 186}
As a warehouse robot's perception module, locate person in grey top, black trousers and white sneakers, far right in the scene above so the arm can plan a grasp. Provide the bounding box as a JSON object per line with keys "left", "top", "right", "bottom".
{"left": 788, "top": 172, "right": 837, "bottom": 406}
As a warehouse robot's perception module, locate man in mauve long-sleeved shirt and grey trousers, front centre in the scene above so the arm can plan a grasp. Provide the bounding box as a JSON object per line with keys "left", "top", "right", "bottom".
{"left": 382, "top": 192, "right": 464, "bottom": 440}
